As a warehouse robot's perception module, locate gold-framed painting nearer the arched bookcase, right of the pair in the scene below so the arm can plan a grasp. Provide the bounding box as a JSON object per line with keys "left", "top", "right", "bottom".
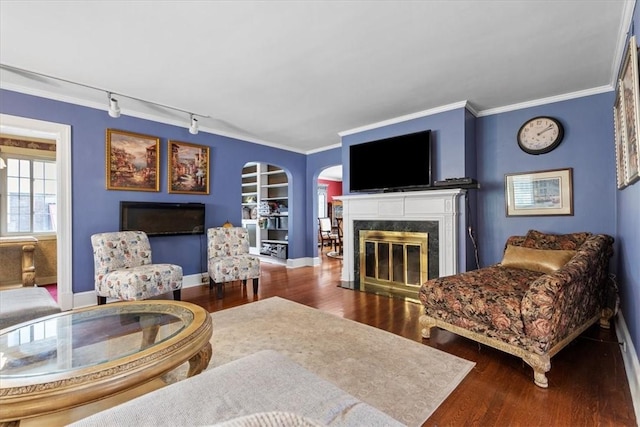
{"left": 168, "top": 141, "right": 209, "bottom": 194}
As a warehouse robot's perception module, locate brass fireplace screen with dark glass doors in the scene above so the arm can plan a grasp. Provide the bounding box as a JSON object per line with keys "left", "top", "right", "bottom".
{"left": 360, "top": 230, "right": 429, "bottom": 301}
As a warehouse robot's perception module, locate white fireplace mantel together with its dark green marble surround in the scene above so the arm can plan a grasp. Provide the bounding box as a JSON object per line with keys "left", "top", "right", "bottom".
{"left": 335, "top": 189, "right": 466, "bottom": 289}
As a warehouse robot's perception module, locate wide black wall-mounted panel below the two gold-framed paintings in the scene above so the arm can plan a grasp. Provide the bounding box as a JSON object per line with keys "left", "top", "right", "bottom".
{"left": 120, "top": 201, "right": 205, "bottom": 236}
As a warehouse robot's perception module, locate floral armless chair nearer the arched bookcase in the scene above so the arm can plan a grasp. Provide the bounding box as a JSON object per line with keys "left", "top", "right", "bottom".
{"left": 207, "top": 227, "right": 260, "bottom": 298}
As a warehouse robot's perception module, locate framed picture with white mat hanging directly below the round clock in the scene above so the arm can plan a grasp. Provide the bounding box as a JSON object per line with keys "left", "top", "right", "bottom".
{"left": 504, "top": 168, "right": 573, "bottom": 216}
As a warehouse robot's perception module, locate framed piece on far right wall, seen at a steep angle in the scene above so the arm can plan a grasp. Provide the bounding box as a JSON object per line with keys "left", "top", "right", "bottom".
{"left": 618, "top": 36, "right": 640, "bottom": 185}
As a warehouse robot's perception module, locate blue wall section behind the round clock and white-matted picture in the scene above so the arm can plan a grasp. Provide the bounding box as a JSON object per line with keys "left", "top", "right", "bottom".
{"left": 476, "top": 92, "right": 616, "bottom": 265}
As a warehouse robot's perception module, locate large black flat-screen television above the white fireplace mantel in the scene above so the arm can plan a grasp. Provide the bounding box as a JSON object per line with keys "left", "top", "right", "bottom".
{"left": 349, "top": 130, "right": 432, "bottom": 193}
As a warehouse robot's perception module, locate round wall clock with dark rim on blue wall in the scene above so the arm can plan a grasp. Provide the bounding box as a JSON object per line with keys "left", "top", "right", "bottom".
{"left": 518, "top": 116, "right": 564, "bottom": 154}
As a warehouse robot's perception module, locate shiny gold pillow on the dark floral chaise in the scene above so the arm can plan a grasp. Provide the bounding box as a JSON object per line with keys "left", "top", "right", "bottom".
{"left": 501, "top": 245, "right": 576, "bottom": 273}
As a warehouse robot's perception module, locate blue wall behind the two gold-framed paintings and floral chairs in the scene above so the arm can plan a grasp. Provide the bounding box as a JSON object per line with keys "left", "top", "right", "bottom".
{"left": 0, "top": 90, "right": 308, "bottom": 293}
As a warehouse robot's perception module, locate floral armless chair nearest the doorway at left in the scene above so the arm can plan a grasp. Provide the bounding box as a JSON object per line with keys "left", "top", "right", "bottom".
{"left": 91, "top": 231, "right": 182, "bottom": 304}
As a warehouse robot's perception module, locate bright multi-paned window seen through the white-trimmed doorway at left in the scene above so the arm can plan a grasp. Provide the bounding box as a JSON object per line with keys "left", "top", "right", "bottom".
{"left": 2, "top": 154, "right": 57, "bottom": 235}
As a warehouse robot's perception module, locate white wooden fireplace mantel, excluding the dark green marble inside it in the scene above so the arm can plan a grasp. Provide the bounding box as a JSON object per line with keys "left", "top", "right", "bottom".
{"left": 334, "top": 189, "right": 466, "bottom": 289}
